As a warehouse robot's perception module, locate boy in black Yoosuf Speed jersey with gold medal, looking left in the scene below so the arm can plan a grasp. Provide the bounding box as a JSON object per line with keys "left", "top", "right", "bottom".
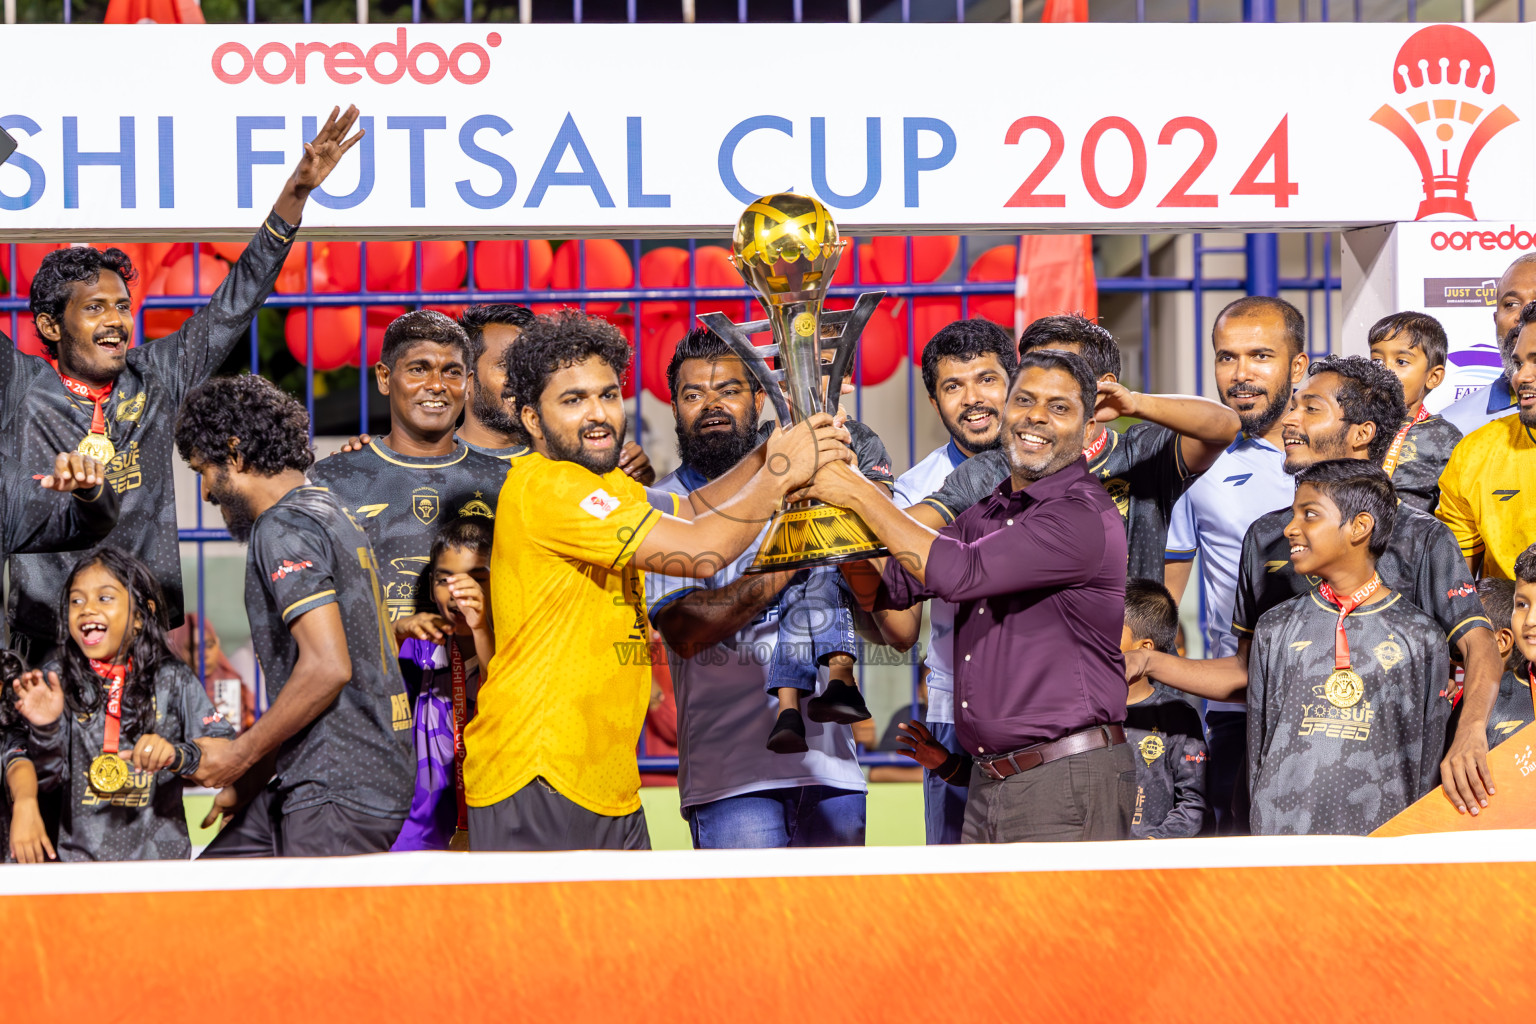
{"left": 1247, "top": 459, "right": 1450, "bottom": 835}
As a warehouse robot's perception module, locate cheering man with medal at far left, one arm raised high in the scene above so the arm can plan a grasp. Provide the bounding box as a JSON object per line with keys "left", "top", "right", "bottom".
{"left": 0, "top": 107, "right": 361, "bottom": 662}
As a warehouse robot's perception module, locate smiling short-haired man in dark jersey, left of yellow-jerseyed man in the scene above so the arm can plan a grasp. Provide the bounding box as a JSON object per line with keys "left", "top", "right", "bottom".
{"left": 309, "top": 310, "right": 507, "bottom": 657}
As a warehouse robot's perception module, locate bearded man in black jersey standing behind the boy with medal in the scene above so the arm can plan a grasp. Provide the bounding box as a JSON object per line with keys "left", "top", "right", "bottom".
{"left": 1126, "top": 356, "right": 1504, "bottom": 829}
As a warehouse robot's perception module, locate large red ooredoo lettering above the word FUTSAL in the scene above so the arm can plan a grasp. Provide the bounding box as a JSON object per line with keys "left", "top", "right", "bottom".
{"left": 212, "top": 28, "right": 501, "bottom": 86}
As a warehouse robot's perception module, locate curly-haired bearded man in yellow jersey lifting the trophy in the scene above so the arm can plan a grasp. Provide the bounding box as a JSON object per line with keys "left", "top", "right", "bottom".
{"left": 464, "top": 310, "right": 852, "bottom": 851}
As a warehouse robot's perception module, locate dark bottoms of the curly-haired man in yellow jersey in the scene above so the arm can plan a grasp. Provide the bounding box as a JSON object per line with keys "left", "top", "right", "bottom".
{"left": 470, "top": 778, "right": 651, "bottom": 851}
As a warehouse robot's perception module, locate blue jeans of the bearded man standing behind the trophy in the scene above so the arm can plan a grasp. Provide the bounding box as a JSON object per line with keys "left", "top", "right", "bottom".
{"left": 684, "top": 786, "right": 865, "bottom": 851}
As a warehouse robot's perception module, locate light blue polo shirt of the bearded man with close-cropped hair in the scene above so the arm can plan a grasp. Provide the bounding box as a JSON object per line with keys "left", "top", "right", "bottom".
{"left": 1163, "top": 434, "right": 1296, "bottom": 711}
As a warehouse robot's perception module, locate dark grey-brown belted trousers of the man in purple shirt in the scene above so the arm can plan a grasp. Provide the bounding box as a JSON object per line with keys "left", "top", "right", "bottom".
{"left": 960, "top": 743, "right": 1137, "bottom": 843}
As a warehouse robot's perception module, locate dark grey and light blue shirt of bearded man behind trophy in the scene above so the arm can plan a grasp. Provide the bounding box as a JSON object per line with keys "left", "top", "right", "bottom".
{"left": 645, "top": 465, "right": 868, "bottom": 808}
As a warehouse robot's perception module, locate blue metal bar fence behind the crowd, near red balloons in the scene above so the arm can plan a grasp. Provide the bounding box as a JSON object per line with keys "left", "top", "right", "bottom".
{"left": 0, "top": 0, "right": 1525, "bottom": 771}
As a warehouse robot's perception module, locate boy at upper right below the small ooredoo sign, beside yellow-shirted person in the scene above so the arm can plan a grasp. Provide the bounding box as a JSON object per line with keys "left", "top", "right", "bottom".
{"left": 1369, "top": 312, "right": 1461, "bottom": 511}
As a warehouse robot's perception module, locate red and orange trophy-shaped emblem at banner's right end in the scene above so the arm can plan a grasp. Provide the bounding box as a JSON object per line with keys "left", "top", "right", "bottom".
{"left": 1370, "top": 25, "right": 1519, "bottom": 221}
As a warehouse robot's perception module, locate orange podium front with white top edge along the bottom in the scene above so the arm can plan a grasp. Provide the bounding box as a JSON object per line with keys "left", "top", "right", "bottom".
{"left": 0, "top": 832, "right": 1536, "bottom": 1024}
